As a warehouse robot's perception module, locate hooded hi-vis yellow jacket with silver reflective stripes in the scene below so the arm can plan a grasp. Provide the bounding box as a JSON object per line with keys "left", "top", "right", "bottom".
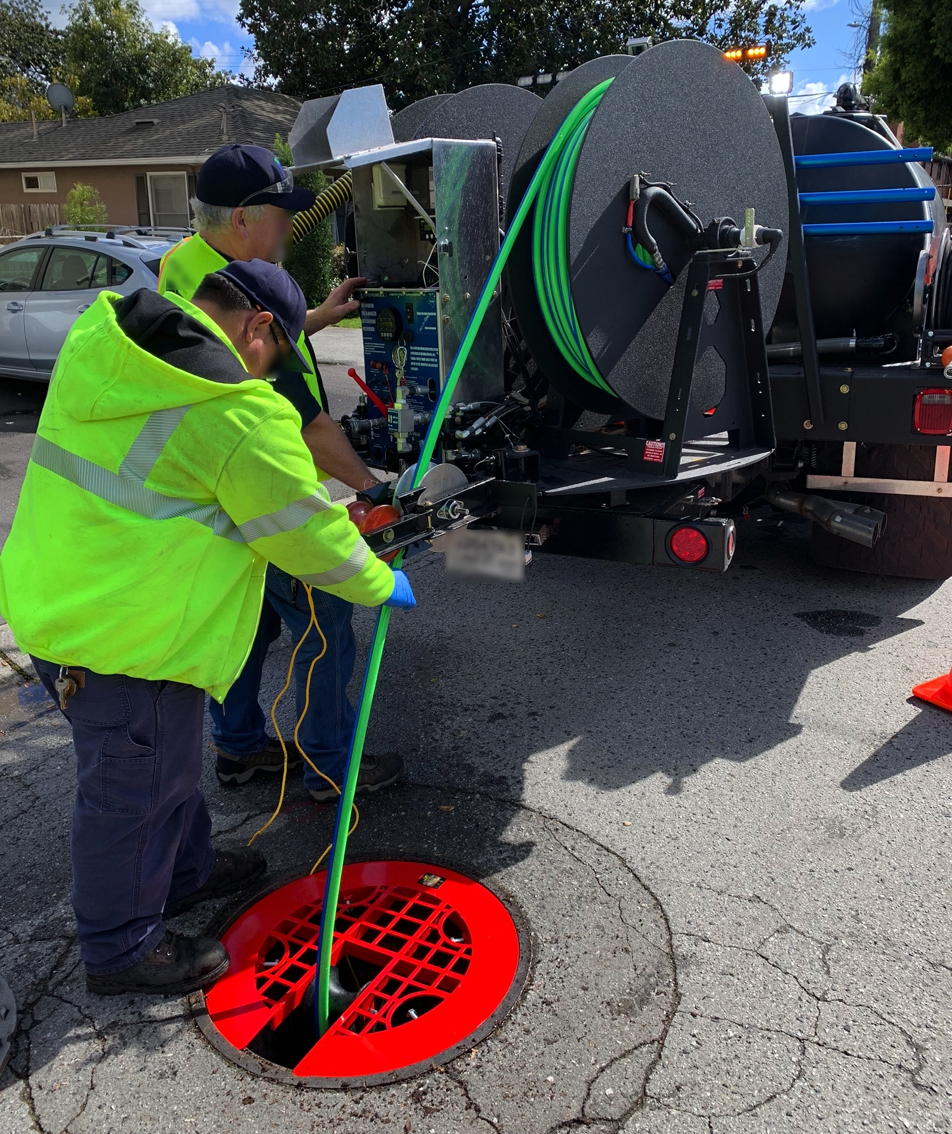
{"left": 0, "top": 291, "right": 393, "bottom": 701}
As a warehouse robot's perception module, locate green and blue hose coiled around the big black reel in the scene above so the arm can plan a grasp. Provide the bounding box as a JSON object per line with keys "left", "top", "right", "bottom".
{"left": 533, "top": 79, "right": 614, "bottom": 395}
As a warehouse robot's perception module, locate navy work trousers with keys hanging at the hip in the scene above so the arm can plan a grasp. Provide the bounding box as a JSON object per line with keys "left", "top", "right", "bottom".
{"left": 33, "top": 658, "right": 215, "bottom": 976}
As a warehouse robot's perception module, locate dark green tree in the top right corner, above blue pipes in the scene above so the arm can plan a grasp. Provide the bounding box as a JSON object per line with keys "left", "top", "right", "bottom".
{"left": 862, "top": 0, "right": 952, "bottom": 153}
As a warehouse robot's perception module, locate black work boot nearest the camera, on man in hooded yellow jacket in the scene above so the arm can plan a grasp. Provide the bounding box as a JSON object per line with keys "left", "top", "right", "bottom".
{"left": 86, "top": 930, "right": 228, "bottom": 996}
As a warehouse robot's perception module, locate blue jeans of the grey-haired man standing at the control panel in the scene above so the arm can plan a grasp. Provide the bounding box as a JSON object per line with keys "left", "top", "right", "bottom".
{"left": 209, "top": 564, "right": 357, "bottom": 788}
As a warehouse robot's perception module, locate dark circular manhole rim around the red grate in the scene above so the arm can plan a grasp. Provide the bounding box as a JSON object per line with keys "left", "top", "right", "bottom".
{"left": 188, "top": 855, "right": 534, "bottom": 1091}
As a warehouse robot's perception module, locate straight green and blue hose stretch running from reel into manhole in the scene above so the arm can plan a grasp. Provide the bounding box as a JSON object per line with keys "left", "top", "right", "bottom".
{"left": 314, "top": 79, "right": 612, "bottom": 1036}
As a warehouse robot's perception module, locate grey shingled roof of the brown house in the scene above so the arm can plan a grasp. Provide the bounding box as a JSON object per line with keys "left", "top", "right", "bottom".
{"left": 0, "top": 86, "right": 300, "bottom": 169}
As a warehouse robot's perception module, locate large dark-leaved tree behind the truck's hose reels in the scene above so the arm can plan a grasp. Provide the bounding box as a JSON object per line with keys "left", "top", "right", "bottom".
{"left": 239, "top": 0, "right": 814, "bottom": 109}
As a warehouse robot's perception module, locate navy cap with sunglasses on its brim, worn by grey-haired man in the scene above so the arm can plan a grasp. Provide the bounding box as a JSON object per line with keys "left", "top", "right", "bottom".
{"left": 195, "top": 145, "right": 315, "bottom": 212}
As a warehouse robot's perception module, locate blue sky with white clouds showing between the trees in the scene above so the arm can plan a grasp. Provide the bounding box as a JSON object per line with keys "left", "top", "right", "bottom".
{"left": 50, "top": 0, "right": 865, "bottom": 103}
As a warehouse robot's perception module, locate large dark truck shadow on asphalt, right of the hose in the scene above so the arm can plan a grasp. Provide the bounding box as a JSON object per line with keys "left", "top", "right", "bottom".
{"left": 369, "top": 518, "right": 952, "bottom": 798}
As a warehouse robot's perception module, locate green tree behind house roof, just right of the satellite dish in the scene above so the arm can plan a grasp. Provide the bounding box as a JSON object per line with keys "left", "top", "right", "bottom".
{"left": 63, "top": 0, "right": 231, "bottom": 115}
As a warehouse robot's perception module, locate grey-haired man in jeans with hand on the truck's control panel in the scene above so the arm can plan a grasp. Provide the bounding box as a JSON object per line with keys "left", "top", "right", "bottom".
{"left": 159, "top": 145, "right": 403, "bottom": 803}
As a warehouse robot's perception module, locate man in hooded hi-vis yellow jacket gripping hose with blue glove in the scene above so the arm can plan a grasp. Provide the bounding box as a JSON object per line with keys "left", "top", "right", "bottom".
{"left": 0, "top": 261, "right": 415, "bottom": 995}
